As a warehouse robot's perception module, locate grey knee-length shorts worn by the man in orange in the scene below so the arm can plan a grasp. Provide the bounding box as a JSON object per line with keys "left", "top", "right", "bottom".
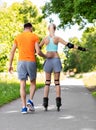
{"left": 17, "top": 61, "right": 37, "bottom": 80}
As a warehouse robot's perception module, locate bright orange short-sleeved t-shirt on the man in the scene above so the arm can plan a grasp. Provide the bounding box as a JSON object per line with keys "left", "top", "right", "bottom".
{"left": 14, "top": 32, "right": 39, "bottom": 62}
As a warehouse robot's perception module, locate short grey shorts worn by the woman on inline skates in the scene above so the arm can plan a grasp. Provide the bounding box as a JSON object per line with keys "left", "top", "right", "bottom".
{"left": 43, "top": 58, "right": 62, "bottom": 73}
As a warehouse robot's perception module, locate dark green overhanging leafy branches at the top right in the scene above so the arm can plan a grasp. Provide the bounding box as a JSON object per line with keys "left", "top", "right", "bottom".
{"left": 42, "top": 0, "right": 96, "bottom": 28}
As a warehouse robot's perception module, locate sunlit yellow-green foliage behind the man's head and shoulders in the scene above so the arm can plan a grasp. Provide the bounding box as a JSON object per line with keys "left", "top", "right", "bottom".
{"left": 0, "top": 0, "right": 46, "bottom": 71}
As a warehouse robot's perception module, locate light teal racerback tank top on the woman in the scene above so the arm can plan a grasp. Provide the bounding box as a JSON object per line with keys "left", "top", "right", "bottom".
{"left": 46, "top": 36, "right": 58, "bottom": 52}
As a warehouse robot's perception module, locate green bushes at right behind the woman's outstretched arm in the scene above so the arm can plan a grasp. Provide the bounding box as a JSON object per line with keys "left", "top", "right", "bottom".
{"left": 65, "top": 27, "right": 96, "bottom": 72}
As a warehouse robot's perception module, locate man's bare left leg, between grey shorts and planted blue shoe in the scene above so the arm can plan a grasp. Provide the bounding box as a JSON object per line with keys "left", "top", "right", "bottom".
{"left": 20, "top": 80, "right": 26, "bottom": 108}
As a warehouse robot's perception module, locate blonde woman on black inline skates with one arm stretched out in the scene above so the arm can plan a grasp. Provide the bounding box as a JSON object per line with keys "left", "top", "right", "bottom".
{"left": 40, "top": 24, "right": 86, "bottom": 111}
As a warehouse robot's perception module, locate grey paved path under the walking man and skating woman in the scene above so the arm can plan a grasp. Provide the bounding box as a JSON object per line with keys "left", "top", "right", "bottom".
{"left": 0, "top": 79, "right": 96, "bottom": 130}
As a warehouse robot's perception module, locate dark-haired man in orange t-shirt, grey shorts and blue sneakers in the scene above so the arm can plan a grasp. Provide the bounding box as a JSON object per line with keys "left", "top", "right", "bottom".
{"left": 9, "top": 23, "right": 46, "bottom": 113}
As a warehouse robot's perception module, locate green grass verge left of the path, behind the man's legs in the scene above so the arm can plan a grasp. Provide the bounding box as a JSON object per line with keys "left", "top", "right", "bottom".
{"left": 0, "top": 74, "right": 44, "bottom": 106}
